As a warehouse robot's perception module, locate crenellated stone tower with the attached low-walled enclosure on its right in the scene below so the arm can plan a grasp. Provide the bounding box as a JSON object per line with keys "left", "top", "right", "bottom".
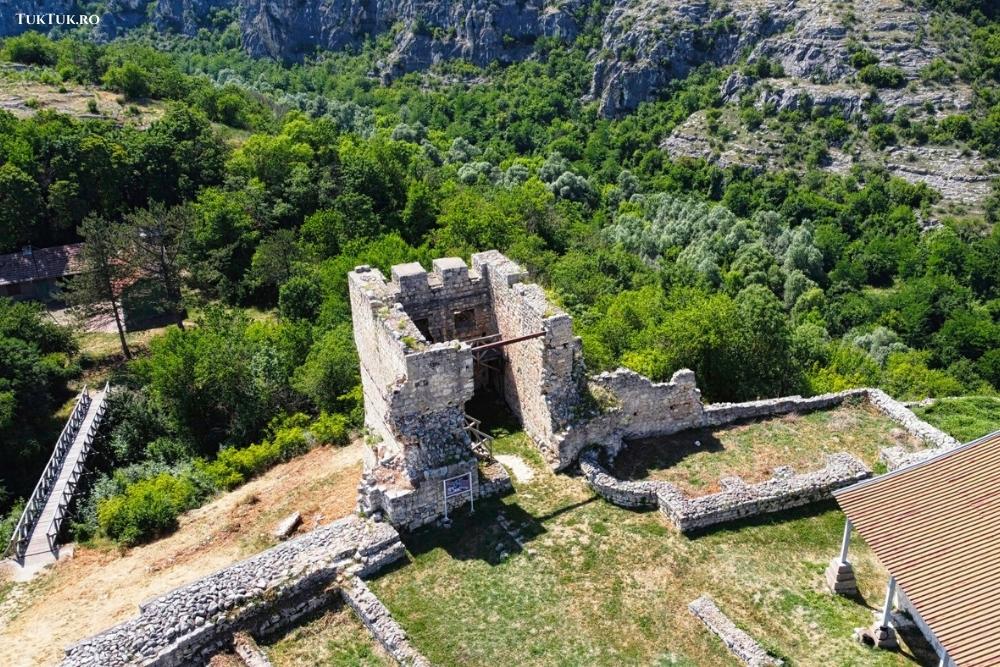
{"left": 348, "top": 250, "right": 958, "bottom": 531}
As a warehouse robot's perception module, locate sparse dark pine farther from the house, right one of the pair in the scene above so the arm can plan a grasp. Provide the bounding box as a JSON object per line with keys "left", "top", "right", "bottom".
{"left": 124, "top": 203, "right": 193, "bottom": 329}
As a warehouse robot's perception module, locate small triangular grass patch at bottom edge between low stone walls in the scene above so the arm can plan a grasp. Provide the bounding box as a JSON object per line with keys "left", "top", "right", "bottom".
{"left": 265, "top": 607, "right": 395, "bottom": 667}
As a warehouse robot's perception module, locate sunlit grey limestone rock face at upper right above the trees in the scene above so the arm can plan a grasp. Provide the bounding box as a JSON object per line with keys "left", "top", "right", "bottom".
{"left": 589, "top": 0, "right": 941, "bottom": 116}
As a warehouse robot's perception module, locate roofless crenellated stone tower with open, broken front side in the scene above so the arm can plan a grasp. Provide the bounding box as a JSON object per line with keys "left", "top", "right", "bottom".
{"left": 348, "top": 250, "right": 583, "bottom": 529}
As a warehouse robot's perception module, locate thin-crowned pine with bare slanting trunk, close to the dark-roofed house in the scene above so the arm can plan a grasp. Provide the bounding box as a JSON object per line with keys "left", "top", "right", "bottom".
{"left": 67, "top": 215, "right": 135, "bottom": 359}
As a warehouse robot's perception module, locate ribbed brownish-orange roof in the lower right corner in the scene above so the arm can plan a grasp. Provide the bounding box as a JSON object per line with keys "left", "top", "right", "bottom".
{"left": 834, "top": 431, "right": 1000, "bottom": 667}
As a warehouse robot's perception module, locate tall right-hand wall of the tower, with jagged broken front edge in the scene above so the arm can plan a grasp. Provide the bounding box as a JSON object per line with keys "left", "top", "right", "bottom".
{"left": 472, "top": 250, "right": 583, "bottom": 444}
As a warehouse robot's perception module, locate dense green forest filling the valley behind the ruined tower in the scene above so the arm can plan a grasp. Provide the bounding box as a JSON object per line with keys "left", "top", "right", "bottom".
{"left": 0, "top": 2, "right": 1000, "bottom": 543}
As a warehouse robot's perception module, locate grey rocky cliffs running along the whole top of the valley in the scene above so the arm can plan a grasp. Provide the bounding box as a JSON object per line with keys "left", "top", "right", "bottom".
{"left": 0, "top": 0, "right": 964, "bottom": 116}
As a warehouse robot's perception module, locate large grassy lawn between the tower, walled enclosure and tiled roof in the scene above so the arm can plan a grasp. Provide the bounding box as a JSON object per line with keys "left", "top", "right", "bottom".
{"left": 372, "top": 444, "right": 936, "bottom": 667}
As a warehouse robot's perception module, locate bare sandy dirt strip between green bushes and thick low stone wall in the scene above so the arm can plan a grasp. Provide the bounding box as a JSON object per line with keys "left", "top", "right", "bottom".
{"left": 0, "top": 443, "right": 364, "bottom": 667}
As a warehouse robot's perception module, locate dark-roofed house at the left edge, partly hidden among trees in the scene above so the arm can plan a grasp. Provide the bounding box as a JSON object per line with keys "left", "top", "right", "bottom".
{"left": 0, "top": 243, "right": 84, "bottom": 302}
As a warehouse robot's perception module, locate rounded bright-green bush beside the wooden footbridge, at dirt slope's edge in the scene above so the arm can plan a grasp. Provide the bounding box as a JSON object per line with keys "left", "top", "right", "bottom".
{"left": 97, "top": 473, "right": 201, "bottom": 546}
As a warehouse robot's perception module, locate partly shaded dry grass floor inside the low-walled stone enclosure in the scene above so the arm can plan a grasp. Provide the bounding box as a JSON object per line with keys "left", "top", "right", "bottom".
{"left": 615, "top": 405, "right": 923, "bottom": 494}
